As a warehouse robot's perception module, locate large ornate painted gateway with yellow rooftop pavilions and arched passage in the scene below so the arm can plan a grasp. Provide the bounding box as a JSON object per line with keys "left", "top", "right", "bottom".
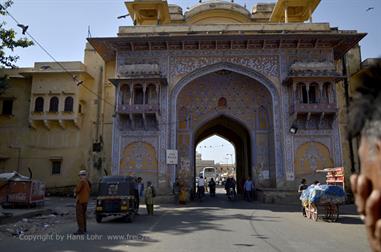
{"left": 89, "top": 0, "right": 364, "bottom": 193}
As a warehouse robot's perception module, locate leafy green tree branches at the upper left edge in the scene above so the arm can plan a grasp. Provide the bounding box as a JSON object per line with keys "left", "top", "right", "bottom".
{"left": 0, "top": 0, "right": 33, "bottom": 68}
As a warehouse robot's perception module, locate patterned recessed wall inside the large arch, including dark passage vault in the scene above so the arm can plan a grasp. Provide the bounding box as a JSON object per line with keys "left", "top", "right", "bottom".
{"left": 174, "top": 64, "right": 276, "bottom": 186}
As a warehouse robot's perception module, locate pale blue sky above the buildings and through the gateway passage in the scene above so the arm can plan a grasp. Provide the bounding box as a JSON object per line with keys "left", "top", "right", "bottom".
{"left": 0, "top": 0, "right": 381, "bottom": 162}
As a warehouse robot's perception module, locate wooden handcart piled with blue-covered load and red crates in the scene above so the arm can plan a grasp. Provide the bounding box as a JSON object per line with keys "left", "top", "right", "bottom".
{"left": 300, "top": 167, "right": 346, "bottom": 222}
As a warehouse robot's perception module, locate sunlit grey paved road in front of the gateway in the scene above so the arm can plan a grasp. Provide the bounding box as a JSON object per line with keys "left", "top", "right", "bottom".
{"left": 0, "top": 191, "right": 370, "bottom": 252}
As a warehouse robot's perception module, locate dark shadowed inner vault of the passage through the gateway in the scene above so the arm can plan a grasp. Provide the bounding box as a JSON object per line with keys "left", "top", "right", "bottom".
{"left": 193, "top": 115, "right": 252, "bottom": 193}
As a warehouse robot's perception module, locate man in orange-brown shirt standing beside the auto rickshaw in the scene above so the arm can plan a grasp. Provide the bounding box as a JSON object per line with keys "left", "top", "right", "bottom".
{"left": 74, "top": 170, "right": 91, "bottom": 235}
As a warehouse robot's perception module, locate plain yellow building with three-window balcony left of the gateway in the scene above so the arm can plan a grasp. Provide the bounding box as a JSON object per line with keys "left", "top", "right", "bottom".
{"left": 0, "top": 47, "right": 114, "bottom": 194}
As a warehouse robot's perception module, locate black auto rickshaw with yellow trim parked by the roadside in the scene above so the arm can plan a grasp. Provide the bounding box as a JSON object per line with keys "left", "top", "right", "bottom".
{"left": 95, "top": 176, "right": 139, "bottom": 223}
